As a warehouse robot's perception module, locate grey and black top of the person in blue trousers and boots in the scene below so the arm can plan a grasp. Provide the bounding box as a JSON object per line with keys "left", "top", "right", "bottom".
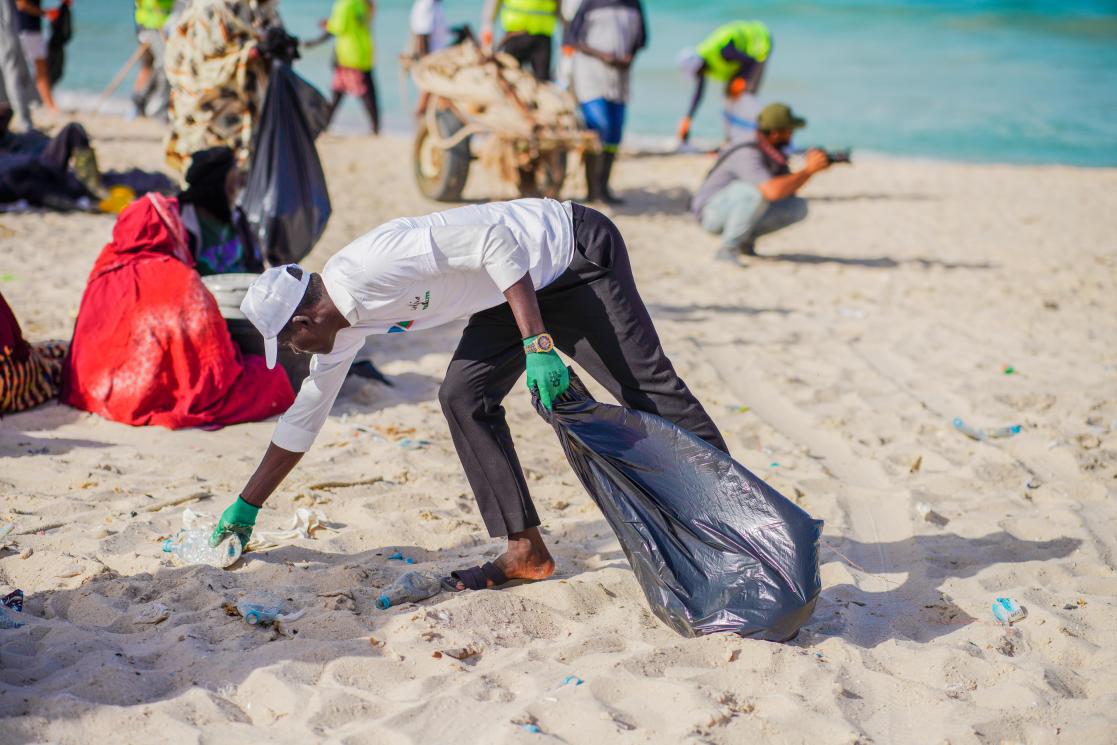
{"left": 564, "top": 0, "right": 648, "bottom": 103}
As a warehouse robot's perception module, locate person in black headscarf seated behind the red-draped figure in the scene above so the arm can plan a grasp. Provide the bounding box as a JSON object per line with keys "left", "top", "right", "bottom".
{"left": 179, "top": 147, "right": 264, "bottom": 276}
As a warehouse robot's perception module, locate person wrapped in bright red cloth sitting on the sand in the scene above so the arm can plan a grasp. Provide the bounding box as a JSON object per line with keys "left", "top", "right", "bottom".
{"left": 60, "top": 193, "right": 295, "bottom": 429}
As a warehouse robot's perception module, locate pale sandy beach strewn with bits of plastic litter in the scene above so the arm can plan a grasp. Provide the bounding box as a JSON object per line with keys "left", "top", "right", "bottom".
{"left": 0, "top": 113, "right": 1117, "bottom": 745}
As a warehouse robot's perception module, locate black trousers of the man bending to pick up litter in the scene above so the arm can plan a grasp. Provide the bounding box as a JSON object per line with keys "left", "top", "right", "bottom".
{"left": 439, "top": 204, "right": 728, "bottom": 536}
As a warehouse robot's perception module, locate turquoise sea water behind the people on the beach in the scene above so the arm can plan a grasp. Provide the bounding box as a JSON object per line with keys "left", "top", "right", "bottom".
{"left": 56, "top": 0, "right": 1117, "bottom": 165}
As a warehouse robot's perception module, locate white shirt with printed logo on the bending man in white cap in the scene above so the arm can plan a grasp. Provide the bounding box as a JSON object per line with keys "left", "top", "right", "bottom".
{"left": 271, "top": 199, "right": 574, "bottom": 452}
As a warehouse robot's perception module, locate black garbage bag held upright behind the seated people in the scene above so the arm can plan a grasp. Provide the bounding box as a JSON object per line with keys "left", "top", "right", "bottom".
{"left": 240, "top": 60, "right": 331, "bottom": 266}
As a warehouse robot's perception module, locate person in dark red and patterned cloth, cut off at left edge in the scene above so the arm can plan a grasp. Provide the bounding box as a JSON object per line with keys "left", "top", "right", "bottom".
{"left": 0, "top": 295, "right": 67, "bottom": 417}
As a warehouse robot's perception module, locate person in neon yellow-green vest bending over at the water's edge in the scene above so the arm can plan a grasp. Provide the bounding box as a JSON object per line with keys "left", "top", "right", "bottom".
{"left": 678, "top": 21, "right": 772, "bottom": 144}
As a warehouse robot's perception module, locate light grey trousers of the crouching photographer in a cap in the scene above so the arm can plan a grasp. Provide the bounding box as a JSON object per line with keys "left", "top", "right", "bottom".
{"left": 701, "top": 181, "right": 806, "bottom": 249}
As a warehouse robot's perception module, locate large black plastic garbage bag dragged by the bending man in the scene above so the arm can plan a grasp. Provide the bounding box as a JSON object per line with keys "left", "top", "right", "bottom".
{"left": 535, "top": 374, "right": 822, "bottom": 641}
